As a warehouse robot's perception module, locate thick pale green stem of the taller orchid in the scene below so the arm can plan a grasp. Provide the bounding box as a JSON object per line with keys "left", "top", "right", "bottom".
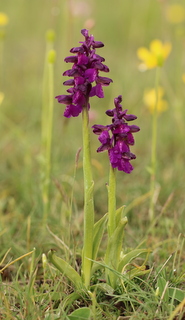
{"left": 82, "top": 102, "right": 94, "bottom": 287}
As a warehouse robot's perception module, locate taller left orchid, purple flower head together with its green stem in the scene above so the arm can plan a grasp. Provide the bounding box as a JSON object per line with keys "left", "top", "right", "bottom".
{"left": 53, "top": 29, "right": 112, "bottom": 288}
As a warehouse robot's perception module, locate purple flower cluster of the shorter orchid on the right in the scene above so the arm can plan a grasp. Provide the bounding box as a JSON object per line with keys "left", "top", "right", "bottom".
{"left": 92, "top": 96, "right": 140, "bottom": 173}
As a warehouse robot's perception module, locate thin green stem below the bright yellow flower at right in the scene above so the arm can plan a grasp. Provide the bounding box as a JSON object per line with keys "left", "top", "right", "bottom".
{"left": 149, "top": 68, "right": 160, "bottom": 221}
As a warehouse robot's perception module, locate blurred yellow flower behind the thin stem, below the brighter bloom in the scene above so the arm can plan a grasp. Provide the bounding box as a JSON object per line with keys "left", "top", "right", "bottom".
{"left": 143, "top": 87, "right": 168, "bottom": 113}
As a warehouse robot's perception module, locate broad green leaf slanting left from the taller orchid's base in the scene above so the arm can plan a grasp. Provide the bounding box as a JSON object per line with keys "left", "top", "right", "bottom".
{"left": 48, "top": 250, "right": 83, "bottom": 289}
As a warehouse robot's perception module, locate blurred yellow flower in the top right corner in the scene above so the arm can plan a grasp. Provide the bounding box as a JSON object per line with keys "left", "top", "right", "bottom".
{"left": 166, "top": 4, "right": 185, "bottom": 24}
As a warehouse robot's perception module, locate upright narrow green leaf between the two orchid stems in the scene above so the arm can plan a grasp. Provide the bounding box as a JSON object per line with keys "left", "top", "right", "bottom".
{"left": 92, "top": 213, "right": 108, "bottom": 260}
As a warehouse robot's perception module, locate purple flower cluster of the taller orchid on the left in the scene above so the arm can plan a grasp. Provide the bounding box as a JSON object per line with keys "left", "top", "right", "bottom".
{"left": 56, "top": 29, "right": 112, "bottom": 118}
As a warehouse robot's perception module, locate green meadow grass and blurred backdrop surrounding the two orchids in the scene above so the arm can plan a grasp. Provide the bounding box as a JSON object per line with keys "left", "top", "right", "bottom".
{"left": 0, "top": 0, "right": 185, "bottom": 320}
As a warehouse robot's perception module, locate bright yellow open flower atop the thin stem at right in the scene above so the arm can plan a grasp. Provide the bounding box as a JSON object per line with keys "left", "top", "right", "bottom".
{"left": 137, "top": 40, "right": 171, "bottom": 71}
